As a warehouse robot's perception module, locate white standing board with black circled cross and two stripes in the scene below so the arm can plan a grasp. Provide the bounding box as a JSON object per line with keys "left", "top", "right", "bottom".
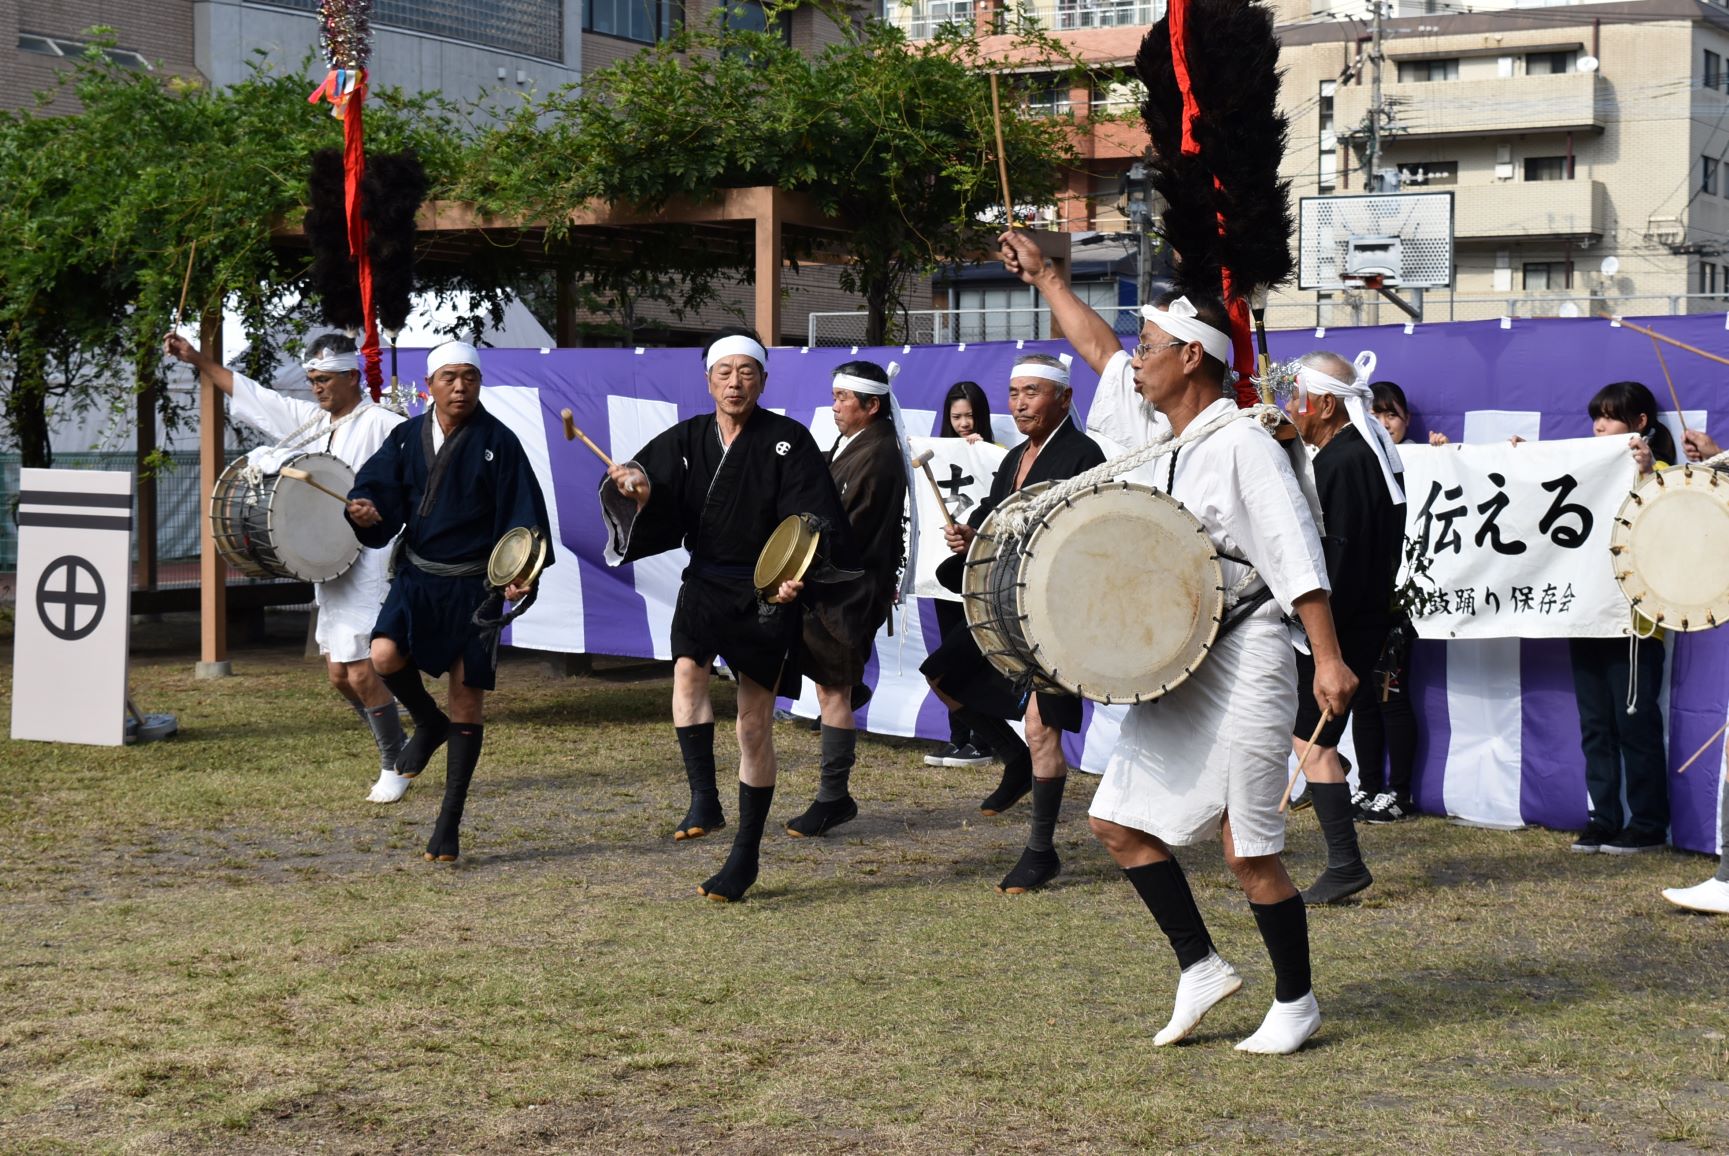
{"left": 12, "top": 470, "right": 131, "bottom": 746}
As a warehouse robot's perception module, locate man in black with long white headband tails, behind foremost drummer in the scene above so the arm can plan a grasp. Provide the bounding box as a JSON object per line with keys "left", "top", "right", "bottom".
{"left": 1286, "top": 353, "right": 1409, "bottom": 905}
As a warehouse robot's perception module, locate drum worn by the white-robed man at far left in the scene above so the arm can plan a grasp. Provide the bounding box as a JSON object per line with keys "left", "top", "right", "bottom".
{"left": 209, "top": 451, "right": 360, "bottom": 582}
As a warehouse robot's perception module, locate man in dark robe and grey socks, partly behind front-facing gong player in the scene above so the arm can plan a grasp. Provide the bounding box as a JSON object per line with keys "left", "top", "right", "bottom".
{"left": 787, "top": 361, "right": 908, "bottom": 836}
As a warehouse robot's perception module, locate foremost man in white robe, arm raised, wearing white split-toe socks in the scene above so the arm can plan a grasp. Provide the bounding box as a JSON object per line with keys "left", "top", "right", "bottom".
{"left": 1001, "top": 232, "right": 1356, "bottom": 1054}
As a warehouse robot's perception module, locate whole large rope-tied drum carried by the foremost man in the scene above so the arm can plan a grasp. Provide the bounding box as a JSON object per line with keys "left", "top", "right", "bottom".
{"left": 961, "top": 480, "right": 1226, "bottom": 703}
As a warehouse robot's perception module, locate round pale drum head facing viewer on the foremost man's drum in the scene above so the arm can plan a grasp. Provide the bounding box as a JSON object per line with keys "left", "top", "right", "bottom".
{"left": 1020, "top": 482, "right": 1224, "bottom": 703}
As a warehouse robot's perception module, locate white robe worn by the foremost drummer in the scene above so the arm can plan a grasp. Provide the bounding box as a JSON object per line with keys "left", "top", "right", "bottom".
{"left": 1088, "top": 353, "right": 1328, "bottom": 855}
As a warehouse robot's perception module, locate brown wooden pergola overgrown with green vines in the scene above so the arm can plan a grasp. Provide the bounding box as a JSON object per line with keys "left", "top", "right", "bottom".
{"left": 196, "top": 185, "right": 1069, "bottom": 677}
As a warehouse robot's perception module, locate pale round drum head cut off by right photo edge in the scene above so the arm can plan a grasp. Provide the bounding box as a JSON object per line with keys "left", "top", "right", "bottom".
{"left": 1610, "top": 465, "right": 1729, "bottom": 631}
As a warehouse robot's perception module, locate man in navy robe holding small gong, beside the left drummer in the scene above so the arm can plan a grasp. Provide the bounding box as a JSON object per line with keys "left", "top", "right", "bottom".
{"left": 348, "top": 340, "right": 552, "bottom": 862}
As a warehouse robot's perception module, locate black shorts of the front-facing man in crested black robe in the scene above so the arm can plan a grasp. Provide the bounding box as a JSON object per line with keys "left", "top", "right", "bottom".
{"left": 671, "top": 570, "right": 804, "bottom": 698}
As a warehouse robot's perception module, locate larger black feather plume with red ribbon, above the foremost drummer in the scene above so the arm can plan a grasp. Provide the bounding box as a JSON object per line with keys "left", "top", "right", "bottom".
{"left": 1134, "top": 0, "right": 1295, "bottom": 295}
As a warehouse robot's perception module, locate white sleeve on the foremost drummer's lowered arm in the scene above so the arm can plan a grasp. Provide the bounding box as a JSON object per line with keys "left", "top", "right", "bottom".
{"left": 1224, "top": 430, "right": 1331, "bottom": 613}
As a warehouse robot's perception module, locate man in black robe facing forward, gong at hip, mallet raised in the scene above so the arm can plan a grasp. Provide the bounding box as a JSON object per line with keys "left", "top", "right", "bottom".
{"left": 600, "top": 328, "right": 852, "bottom": 902}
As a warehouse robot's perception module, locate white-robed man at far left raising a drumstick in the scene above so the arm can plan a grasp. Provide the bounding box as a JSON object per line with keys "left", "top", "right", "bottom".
{"left": 163, "top": 333, "right": 413, "bottom": 803}
